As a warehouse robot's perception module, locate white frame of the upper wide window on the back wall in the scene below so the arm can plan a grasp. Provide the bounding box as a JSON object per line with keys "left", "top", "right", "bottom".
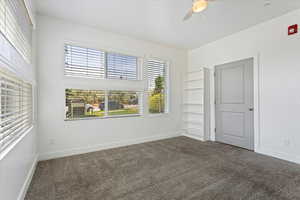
{"left": 63, "top": 42, "right": 143, "bottom": 81}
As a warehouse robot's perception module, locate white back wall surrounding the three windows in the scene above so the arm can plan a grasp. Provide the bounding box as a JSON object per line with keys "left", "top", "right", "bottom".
{"left": 37, "top": 16, "right": 187, "bottom": 159}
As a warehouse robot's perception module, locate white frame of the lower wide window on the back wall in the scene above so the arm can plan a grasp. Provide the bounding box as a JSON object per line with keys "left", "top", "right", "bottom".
{"left": 64, "top": 87, "right": 144, "bottom": 121}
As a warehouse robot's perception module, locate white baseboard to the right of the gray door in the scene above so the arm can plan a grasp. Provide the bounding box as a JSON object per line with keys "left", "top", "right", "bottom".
{"left": 255, "top": 147, "right": 300, "bottom": 164}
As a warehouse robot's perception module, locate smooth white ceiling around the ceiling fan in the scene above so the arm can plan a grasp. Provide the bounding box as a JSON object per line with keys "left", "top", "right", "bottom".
{"left": 36, "top": 0, "right": 300, "bottom": 49}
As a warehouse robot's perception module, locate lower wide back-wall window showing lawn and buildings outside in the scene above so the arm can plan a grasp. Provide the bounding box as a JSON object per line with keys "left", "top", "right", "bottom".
{"left": 65, "top": 89, "right": 140, "bottom": 120}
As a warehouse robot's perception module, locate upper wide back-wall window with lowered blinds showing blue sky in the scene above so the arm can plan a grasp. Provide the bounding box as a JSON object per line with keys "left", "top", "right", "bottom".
{"left": 65, "top": 45, "right": 138, "bottom": 80}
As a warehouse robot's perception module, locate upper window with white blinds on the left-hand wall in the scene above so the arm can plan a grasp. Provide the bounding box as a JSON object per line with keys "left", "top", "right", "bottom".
{"left": 0, "top": 0, "right": 32, "bottom": 63}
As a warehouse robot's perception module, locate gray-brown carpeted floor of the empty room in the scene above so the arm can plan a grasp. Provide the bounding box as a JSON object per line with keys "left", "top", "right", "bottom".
{"left": 25, "top": 137, "right": 300, "bottom": 200}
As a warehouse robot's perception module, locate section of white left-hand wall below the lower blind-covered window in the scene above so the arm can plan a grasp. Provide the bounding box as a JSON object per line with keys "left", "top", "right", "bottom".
{"left": 0, "top": 127, "right": 38, "bottom": 200}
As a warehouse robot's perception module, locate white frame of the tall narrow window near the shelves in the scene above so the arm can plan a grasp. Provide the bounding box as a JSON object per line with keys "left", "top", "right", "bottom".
{"left": 144, "top": 57, "right": 171, "bottom": 117}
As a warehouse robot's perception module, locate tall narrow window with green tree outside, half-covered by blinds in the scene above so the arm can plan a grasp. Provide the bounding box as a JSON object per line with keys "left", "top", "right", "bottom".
{"left": 147, "top": 59, "right": 168, "bottom": 114}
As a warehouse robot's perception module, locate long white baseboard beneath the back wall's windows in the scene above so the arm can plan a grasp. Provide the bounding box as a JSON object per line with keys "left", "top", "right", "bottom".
{"left": 39, "top": 133, "right": 181, "bottom": 161}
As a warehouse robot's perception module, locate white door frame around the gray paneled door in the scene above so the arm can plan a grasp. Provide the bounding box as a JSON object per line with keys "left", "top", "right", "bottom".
{"left": 210, "top": 53, "right": 261, "bottom": 152}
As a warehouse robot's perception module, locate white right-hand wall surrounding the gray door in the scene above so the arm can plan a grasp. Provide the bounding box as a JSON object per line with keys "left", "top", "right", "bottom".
{"left": 188, "top": 10, "right": 300, "bottom": 163}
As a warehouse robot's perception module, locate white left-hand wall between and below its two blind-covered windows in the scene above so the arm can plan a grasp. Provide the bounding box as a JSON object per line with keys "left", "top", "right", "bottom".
{"left": 0, "top": 0, "right": 38, "bottom": 200}
